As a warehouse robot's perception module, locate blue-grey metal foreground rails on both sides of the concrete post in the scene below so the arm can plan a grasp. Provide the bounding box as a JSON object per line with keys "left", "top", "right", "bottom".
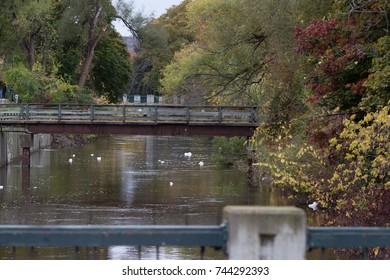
{"left": 0, "top": 224, "right": 390, "bottom": 259}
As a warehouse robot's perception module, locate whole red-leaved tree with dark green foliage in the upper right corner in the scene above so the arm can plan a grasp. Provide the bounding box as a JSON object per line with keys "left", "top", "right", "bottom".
{"left": 295, "top": 0, "right": 389, "bottom": 112}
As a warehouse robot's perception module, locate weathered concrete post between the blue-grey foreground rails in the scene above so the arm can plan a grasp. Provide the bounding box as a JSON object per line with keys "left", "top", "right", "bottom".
{"left": 224, "top": 206, "right": 306, "bottom": 260}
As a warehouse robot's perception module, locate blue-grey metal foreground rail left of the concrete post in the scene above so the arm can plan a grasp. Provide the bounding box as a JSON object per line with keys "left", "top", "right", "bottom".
{"left": 0, "top": 224, "right": 227, "bottom": 259}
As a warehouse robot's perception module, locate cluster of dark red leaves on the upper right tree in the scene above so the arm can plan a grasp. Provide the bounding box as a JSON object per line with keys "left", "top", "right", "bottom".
{"left": 294, "top": 18, "right": 366, "bottom": 107}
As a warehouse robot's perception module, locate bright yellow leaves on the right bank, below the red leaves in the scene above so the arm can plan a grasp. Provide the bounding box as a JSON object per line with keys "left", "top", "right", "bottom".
{"left": 253, "top": 108, "right": 390, "bottom": 219}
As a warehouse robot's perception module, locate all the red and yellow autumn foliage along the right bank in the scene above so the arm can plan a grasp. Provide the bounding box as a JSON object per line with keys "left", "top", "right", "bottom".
{"left": 257, "top": 0, "right": 390, "bottom": 245}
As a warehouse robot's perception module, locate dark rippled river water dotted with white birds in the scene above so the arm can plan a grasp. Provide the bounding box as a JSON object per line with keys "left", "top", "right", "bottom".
{"left": 0, "top": 136, "right": 316, "bottom": 259}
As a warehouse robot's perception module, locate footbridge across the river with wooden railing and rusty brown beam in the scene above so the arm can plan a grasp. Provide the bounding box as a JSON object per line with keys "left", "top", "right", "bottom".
{"left": 0, "top": 104, "right": 257, "bottom": 137}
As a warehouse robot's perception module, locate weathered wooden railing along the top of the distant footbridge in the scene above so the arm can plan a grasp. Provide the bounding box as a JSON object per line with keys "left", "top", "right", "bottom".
{"left": 0, "top": 104, "right": 257, "bottom": 124}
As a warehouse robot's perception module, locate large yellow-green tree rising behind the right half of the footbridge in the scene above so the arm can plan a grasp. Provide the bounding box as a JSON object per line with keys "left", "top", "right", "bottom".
{"left": 162, "top": 0, "right": 273, "bottom": 103}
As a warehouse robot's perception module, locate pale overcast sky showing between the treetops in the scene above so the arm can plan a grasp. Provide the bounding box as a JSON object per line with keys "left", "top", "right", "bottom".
{"left": 114, "top": 0, "right": 182, "bottom": 36}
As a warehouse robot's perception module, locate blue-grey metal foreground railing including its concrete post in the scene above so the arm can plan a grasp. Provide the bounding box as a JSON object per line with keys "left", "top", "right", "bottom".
{"left": 0, "top": 206, "right": 390, "bottom": 259}
